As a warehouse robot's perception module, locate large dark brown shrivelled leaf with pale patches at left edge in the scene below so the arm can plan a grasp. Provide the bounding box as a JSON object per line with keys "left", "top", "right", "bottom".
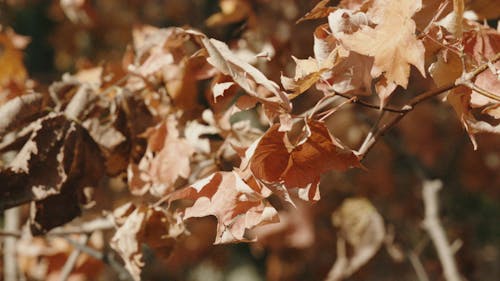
{"left": 0, "top": 113, "right": 103, "bottom": 234}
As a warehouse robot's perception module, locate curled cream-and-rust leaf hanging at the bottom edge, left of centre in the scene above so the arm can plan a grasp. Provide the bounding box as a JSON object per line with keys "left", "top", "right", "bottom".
{"left": 110, "top": 203, "right": 184, "bottom": 281}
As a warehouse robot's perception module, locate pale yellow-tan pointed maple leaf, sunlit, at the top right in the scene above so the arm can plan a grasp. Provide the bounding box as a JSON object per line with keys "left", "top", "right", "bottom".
{"left": 339, "top": 0, "right": 425, "bottom": 100}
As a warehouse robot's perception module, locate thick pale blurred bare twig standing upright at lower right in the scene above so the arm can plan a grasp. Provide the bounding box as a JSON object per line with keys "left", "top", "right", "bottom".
{"left": 422, "top": 180, "right": 462, "bottom": 281}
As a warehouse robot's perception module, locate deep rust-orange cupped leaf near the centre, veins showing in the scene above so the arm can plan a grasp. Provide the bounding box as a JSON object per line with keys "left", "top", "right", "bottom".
{"left": 249, "top": 120, "right": 360, "bottom": 201}
